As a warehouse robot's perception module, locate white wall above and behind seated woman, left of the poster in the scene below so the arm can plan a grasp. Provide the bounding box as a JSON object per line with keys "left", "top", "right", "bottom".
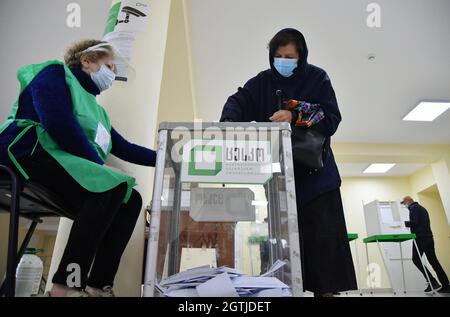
{"left": 0, "top": 0, "right": 111, "bottom": 121}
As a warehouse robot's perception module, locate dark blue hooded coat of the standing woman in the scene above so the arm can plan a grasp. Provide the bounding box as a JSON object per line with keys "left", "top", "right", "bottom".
{"left": 221, "top": 28, "right": 341, "bottom": 206}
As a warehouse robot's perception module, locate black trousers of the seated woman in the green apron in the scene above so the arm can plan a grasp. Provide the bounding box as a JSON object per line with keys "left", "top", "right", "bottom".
{"left": 20, "top": 151, "right": 142, "bottom": 288}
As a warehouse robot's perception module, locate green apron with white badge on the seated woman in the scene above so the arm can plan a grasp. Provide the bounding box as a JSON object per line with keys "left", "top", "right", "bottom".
{"left": 0, "top": 60, "right": 136, "bottom": 203}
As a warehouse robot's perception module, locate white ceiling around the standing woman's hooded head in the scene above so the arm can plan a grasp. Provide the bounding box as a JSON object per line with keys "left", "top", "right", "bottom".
{"left": 187, "top": 0, "right": 450, "bottom": 144}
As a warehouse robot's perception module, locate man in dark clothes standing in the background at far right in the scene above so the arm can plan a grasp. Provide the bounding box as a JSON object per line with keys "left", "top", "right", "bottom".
{"left": 401, "top": 196, "right": 450, "bottom": 293}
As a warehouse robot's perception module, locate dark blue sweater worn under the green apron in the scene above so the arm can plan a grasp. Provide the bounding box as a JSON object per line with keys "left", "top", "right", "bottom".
{"left": 0, "top": 65, "right": 156, "bottom": 166}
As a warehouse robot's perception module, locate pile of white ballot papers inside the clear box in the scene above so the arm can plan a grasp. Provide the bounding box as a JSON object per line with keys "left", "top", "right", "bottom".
{"left": 156, "top": 260, "right": 292, "bottom": 297}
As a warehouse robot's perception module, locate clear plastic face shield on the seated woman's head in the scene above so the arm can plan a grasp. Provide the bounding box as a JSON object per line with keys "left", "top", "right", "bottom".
{"left": 82, "top": 42, "right": 136, "bottom": 82}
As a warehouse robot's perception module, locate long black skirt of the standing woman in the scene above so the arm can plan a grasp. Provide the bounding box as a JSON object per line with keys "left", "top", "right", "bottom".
{"left": 298, "top": 189, "right": 357, "bottom": 294}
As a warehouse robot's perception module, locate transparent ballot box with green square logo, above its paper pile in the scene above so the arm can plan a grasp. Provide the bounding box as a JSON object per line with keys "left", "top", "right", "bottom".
{"left": 144, "top": 122, "right": 303, "bottom": 296}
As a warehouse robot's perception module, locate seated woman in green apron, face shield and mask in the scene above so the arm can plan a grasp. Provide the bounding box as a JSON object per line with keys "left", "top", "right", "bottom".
{"left": 0, "top": 40, "right": 156, "bottom": 297}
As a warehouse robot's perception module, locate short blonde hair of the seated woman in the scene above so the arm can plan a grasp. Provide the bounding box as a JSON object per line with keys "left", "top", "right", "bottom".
{"left": 64, "top": 40, "right": 114, "bottom": 68}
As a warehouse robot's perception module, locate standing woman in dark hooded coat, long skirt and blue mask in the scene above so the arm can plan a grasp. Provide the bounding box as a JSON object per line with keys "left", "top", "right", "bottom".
{"left": 221, "top": 29, "right": 357, "bottom": 296}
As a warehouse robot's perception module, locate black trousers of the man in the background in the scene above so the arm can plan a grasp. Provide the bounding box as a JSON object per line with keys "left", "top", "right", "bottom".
{"left": 413, "top": 236, "right": 449, "bottom": 286}
